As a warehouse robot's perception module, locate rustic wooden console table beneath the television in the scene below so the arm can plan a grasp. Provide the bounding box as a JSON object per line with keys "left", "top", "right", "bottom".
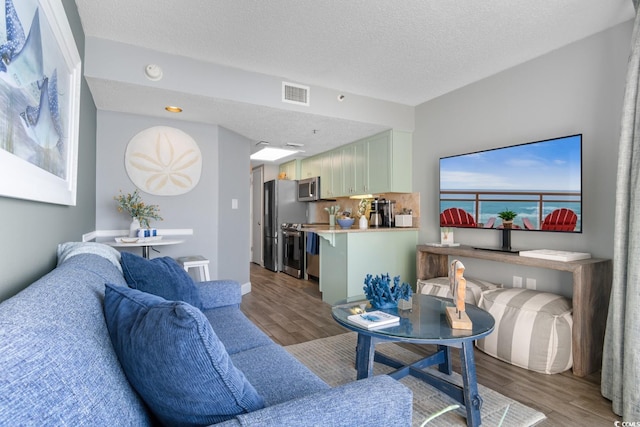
{"left": 416, "top": 245, "right": 613, "bottom": 377}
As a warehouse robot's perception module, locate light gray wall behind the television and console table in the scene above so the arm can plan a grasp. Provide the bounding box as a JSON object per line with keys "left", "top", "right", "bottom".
{"left": 413, "top": 22, "right": 632, "bottom": 294}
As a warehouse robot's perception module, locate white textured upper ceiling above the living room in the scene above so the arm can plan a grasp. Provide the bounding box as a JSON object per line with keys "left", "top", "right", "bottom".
{"left": 76, "top": 0, "right": 633, "bottom": 160}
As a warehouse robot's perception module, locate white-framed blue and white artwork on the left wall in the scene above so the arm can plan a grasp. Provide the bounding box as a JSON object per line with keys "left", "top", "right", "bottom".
{"left": 0, "top": 0, "right": 81, "bottom": 205}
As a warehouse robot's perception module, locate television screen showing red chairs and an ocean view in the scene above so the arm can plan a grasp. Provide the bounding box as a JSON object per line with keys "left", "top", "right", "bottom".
{"left": 440, "top": 135, "right": 582, "bottom": 232}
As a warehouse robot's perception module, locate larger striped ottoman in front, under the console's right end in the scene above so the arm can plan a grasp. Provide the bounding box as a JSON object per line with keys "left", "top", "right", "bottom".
{"left": 476, "top": 288, "right": 573, "bottom": 374}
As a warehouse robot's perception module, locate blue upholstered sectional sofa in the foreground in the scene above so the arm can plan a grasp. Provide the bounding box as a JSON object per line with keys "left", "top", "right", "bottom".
{"left": 0, "top": 243, "right": 412, "bottom": 426}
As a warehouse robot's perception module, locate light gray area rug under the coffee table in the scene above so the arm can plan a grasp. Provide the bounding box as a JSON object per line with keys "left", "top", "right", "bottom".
{"left": 285, "top": 332, "right": 545, "bottom": 427}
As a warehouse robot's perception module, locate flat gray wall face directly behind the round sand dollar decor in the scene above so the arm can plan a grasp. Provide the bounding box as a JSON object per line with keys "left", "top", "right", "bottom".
{"left": 96, "top": 110, "right": 219, "bottom": 277}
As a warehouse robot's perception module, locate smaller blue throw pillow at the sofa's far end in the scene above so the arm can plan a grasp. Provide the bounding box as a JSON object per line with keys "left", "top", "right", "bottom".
{"left": 120, "top": 252, "right": 202, "bottom": 308}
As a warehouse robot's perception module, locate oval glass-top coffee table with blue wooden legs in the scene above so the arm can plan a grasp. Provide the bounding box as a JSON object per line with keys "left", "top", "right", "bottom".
{"left": 332, "top": 294, "right": 495, "bottom": 426}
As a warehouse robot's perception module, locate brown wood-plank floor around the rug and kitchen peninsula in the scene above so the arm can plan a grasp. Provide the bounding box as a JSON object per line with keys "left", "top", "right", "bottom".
{"left": 241, "top": 264, "right": 621, "bottom": 427}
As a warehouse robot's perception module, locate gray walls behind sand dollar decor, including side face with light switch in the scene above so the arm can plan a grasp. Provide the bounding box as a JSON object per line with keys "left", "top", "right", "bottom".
{"left": 96, "top": 110, "right": 250, "bottom": 283}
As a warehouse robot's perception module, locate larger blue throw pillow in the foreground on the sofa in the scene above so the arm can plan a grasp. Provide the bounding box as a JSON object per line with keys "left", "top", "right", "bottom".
{"left": 104, "top": 284, "right": 264, "bottom": 426}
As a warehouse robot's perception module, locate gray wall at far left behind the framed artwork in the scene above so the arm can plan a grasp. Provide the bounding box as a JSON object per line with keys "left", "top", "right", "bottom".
{"left": 0, "top": 0, "right": 96, "bottom": 301}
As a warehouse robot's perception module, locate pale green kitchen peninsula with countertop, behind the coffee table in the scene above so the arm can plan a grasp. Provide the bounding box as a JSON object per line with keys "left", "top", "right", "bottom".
{"left": 305, "top": 226, "right": 418, "bottom": 304}
